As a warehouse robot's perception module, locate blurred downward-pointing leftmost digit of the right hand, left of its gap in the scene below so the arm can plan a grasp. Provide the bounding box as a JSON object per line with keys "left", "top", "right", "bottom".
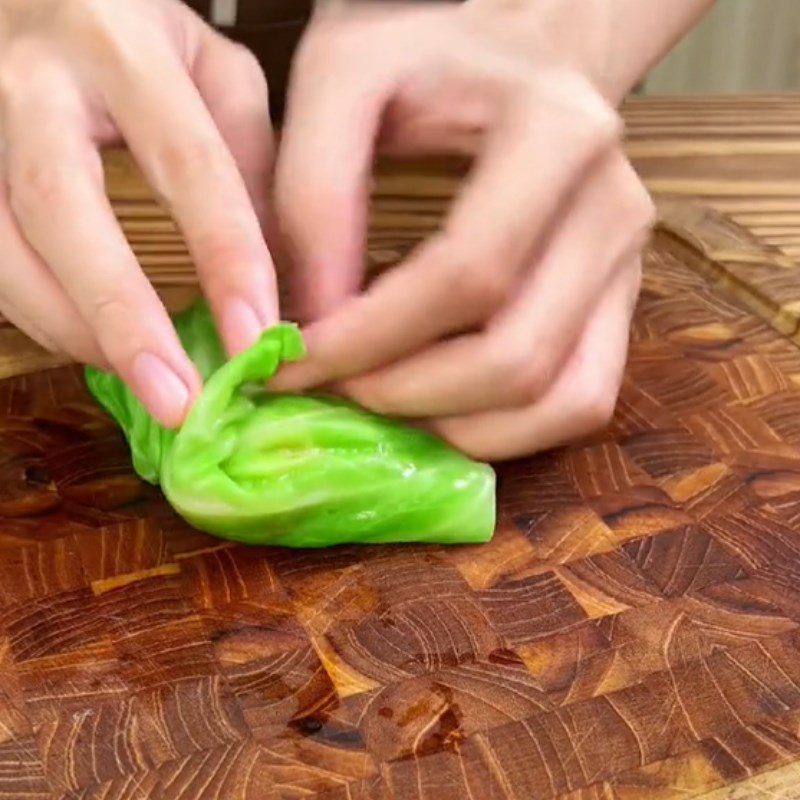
{"left": 275, "top": 16, "right": 391, "bottom": 321}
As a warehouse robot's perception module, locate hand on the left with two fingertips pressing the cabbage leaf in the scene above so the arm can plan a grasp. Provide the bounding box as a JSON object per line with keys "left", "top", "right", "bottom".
{"left": 0, "top": 0, "right": 278, "bottom": 426}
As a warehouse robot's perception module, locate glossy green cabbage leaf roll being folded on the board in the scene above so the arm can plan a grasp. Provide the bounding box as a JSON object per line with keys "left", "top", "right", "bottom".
{"left": 86, "top": 302, "right": 495, "bottom": 547}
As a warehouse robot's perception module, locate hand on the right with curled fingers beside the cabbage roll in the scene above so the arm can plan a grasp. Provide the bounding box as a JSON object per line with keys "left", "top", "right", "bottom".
{"left": 273, "top": 0, "right": 653, "bottom": 459}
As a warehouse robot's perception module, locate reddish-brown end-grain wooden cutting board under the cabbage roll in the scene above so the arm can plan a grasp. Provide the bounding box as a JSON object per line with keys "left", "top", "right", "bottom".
{"left": 0, "top": 100, "right": 800, "bottom": 800}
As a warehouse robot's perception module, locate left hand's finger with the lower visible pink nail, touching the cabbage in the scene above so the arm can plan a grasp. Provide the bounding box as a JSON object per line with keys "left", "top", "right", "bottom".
{"left": 5, "top": 92, "right": 199, "bottom": 426}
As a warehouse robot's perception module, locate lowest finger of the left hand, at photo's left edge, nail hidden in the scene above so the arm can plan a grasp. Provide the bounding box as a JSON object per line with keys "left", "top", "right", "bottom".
{"left": 0, "top": 186, "right": 108, "bottom": 368}
